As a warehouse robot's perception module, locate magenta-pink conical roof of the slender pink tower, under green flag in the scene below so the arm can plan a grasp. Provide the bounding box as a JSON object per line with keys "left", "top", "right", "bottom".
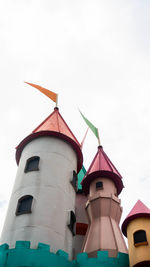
{"left": 81, "top": 146, "right": 123, "bottom": 194}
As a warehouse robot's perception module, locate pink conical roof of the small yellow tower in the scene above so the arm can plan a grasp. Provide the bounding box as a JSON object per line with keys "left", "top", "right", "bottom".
{"left": 122, "top": 200, "right": 150, "bottom": 236}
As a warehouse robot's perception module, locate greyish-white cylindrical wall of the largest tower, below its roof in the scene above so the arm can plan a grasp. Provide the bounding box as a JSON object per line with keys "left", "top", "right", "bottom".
{"left": 1, "top": 137, "right": 77, "bottom": 255}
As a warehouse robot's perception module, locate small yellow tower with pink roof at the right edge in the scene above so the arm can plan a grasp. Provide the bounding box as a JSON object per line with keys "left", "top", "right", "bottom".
{"left": 122, "top": 200, "right": 150, "bottom": 267}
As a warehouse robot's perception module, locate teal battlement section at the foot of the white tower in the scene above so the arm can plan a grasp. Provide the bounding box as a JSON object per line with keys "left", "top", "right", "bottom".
{"left": 0, "top": 241, "right": 73, "bottom": 267}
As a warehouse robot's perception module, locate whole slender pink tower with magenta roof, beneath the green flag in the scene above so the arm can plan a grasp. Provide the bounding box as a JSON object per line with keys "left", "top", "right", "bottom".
{"left": 82, "top": 146, "right": 128, "bottom": 257}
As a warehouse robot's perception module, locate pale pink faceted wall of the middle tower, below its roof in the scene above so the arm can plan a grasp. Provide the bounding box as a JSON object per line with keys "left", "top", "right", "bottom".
{"left": 83, "top": 177, "right": 127, "bottom": 257}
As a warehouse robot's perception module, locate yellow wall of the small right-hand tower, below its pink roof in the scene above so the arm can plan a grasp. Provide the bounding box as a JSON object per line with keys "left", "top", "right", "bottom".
{"left": 127, "top": 218, "right": 150, "bottom": 267}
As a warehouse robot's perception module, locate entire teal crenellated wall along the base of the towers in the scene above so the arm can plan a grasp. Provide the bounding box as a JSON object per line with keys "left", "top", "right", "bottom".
{"left": 0, "top": 241, "right": 129, "bottom": 267}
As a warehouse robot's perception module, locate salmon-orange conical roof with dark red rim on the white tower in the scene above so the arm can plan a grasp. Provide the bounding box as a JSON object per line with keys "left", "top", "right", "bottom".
{"left": 16, "top": 108, "right": 83, "bottom": 174}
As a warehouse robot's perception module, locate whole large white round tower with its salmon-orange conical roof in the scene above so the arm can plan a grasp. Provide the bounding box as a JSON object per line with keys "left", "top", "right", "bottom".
{"left": 1, "top": 108, "right": 82, "bottom": 257}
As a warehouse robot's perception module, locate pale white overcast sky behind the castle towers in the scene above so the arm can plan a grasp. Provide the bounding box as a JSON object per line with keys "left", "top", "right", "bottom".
{"left": 0, "top": 0, "right": 150, "bottom": 241}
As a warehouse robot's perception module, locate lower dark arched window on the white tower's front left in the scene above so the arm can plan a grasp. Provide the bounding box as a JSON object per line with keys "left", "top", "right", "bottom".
{"left": 16, "top": 195, "right": 33, "bottom": 215}
